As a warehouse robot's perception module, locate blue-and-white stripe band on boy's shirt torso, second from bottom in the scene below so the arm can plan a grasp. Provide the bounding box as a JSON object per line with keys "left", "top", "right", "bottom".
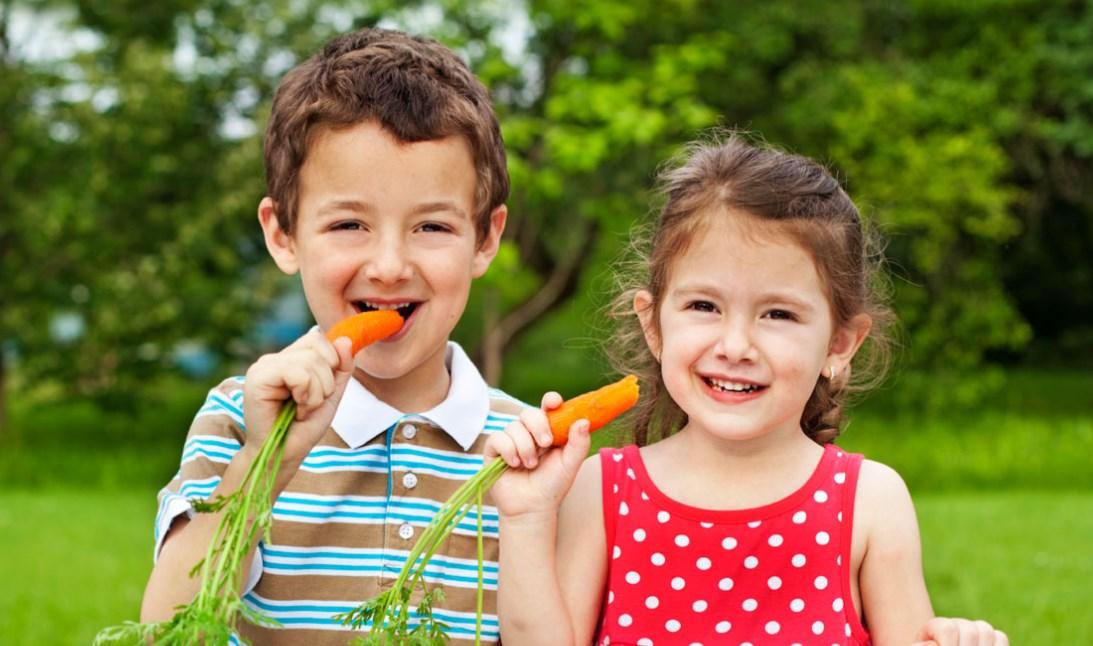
{"left": 261, "top": 544, "right": 497, "bottom": 590}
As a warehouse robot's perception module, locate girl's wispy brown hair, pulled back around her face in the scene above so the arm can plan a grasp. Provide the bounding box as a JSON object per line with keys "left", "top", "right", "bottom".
{"left": 609, "top": 132, "right": 894, "bottom": 445}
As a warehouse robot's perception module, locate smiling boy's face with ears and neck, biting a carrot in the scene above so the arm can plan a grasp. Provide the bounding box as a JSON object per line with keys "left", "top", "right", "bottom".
{"left": 259, "top": 121, "right": 506, "bottom": 410}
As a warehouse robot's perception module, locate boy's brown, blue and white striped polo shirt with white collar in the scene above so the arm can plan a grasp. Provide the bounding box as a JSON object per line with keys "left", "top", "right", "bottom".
{"left": 155, "top": 342, "right": 527, "bottom": 645}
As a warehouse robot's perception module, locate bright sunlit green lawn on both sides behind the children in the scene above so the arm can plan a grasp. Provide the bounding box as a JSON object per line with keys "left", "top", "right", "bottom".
{"left": 0, "top": 489, "right": 1093, "bottom": 646}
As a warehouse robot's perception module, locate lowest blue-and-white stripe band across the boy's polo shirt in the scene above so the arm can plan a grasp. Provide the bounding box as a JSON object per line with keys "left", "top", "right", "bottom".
{"left": 243, "top": 592, "right": 501, "bottom": 642}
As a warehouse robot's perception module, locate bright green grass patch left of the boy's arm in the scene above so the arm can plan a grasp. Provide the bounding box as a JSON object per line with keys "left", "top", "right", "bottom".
{"left": 0, "top": 490, "right": 155, "bottom": 646}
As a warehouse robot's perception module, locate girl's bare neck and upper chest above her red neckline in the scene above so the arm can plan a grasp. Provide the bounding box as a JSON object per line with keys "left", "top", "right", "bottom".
{"left": 642, "top": 426, "right": 823, "bottom": 509}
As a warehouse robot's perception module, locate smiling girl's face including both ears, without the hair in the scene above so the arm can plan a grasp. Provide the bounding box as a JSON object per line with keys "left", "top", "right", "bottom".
{"left": 634, "top": 212, "right": 869, "bottom": 448}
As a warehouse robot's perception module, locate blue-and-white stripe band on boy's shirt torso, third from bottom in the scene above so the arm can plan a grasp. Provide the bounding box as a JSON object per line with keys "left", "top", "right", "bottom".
{"left": 273, "top": 492, "right": 498, "bottom": 538}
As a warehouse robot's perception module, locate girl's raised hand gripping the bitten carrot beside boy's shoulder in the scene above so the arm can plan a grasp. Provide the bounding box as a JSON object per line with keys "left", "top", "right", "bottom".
{"left": 484, "top": 392, "right": 590, "bottom": 517}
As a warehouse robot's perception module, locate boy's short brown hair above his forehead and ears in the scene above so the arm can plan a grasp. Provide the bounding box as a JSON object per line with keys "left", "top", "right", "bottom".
{"left": 265, "top": 28, "right": 508, "bottom": 240}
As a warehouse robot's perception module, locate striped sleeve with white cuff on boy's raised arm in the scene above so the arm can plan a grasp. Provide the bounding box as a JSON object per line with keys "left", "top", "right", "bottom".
{"left": 153, "top": 377, "right": 262, "bottom": 590}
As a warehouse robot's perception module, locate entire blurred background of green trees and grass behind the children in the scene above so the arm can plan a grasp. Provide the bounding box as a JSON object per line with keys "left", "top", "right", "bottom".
{"left": 0, "top": 0, "right": 1093, "bottom": 644}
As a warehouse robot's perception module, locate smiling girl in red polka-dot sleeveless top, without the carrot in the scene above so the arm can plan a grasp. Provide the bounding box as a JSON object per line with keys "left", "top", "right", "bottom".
{"left": 486, "top": 136, "right": 1007, "bottom": 646}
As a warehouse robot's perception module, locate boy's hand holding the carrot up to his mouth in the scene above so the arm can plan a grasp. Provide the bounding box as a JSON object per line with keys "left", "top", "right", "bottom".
{"left": 243, "top": 329, "right": 353, "bottom": 465}
